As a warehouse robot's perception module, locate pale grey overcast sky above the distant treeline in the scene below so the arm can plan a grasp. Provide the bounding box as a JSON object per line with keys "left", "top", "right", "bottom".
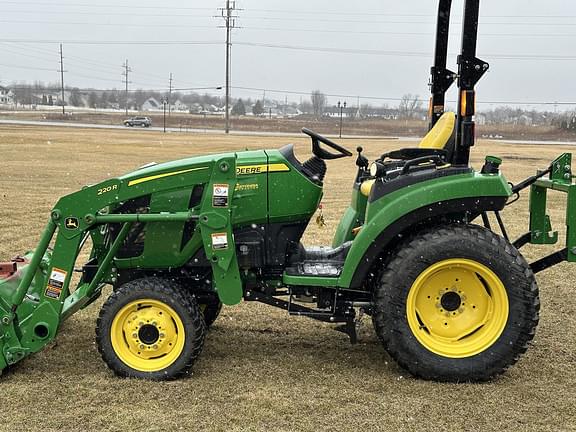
{"left": 0, "top": 0, "right": 576, "bottom": 110}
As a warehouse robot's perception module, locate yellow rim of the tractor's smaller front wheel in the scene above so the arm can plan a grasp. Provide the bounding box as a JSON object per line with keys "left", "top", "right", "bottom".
{"left": 110, "top": 299, "right": 185, "bottom": 372}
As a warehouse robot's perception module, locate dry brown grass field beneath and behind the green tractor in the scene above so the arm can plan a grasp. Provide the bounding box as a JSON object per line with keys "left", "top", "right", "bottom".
{"left": 0, "top": 126, "right": 576, "bottom": 431}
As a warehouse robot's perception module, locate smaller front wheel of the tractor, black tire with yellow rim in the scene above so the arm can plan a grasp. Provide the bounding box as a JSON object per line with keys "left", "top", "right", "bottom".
{"left": 96, "top": 277, "right": 206, "bottom": 380}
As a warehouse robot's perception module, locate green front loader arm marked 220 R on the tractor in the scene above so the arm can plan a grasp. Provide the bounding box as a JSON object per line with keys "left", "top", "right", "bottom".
{"left": 0, "top": 154, "right": 242, "bottom": 370}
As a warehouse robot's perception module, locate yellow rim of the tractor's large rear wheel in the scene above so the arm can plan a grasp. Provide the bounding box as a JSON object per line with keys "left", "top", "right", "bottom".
{"left": 406, "top": 259, "right": 508, "bottom": 358}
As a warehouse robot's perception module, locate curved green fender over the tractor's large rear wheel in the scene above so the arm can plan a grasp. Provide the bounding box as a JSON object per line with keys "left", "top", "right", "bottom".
{"left": 338, "top": 172, "right": 512, "bottom": 289}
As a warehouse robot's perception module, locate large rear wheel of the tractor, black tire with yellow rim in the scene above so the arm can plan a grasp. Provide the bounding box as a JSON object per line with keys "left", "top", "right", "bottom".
{"left": 372, "top": 225, "right": 540, "bottom": 382}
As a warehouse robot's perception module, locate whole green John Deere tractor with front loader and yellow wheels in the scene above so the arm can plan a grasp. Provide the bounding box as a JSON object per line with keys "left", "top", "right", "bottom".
{"left": 0, "top": 0, "right": 576, "bottom": 381}
